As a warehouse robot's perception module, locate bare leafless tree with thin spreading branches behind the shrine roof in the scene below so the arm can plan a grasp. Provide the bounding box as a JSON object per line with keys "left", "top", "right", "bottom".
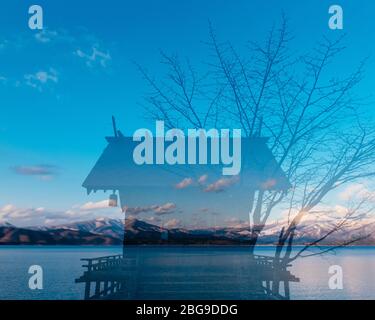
{"left": 139, "top": 17, "right": 375, "bottom": 254}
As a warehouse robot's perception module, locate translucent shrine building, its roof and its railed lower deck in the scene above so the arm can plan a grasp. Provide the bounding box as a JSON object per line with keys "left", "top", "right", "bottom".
{"left": 76, "top": 122, "right": 299, "bottom": 300}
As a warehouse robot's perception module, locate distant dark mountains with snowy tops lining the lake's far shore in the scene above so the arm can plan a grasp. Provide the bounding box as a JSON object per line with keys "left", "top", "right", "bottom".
{"left": 0, "top": 219, "right": 375, "bottom": 248}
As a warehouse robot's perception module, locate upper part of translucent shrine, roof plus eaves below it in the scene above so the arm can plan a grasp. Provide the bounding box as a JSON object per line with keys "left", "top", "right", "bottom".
{"left": 82, "top": 119, "right": 291, "bottom": 220}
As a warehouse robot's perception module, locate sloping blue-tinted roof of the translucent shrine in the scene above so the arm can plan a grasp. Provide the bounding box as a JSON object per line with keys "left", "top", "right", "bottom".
{"left": 83, "top": 136, "right": 290, "bottom": 192}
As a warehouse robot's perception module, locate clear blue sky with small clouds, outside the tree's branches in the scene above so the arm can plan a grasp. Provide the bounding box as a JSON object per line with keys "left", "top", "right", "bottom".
{"left": 0, "top": 0, "right": 375, "bottom": 228}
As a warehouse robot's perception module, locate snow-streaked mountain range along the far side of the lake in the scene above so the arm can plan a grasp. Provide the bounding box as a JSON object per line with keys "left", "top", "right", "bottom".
{"left": 0, "top": 218, "right": 375, "bottom": 245}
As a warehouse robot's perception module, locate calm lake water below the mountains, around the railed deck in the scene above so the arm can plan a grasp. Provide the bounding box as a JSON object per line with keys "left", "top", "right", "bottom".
{"left": 0, "top": 246, "right": 375, "bottom": 299}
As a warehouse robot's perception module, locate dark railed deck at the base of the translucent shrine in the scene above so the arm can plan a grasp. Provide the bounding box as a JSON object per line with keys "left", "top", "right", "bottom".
{"left": 76, "top": 248, "right": 299, "bottom": 300}
